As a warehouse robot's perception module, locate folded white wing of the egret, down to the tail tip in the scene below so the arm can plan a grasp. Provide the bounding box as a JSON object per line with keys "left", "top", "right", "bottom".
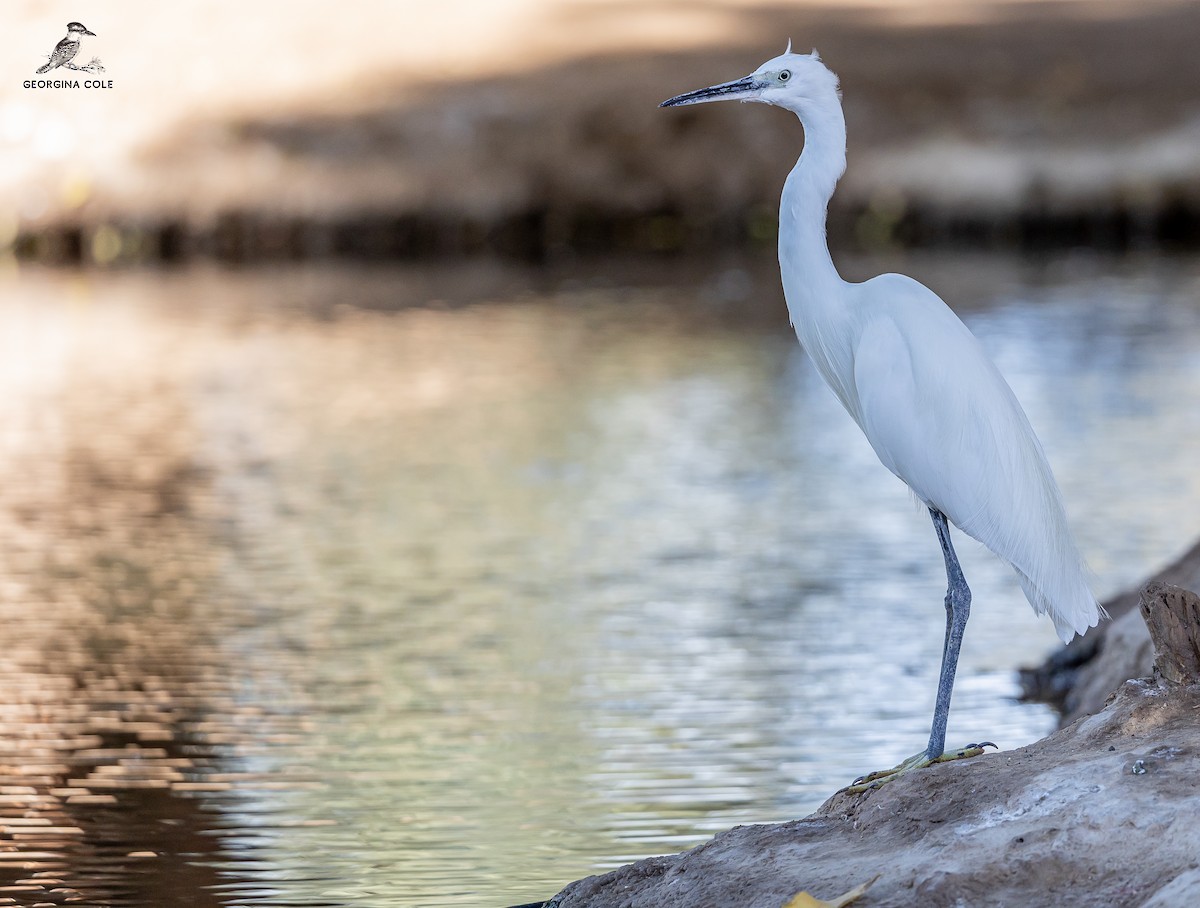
{"left": 854, "top": 276, "right": 1102, "bottom": 638}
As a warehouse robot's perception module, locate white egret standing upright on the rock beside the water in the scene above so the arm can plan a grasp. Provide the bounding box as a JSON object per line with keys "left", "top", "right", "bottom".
{"left": 660, "top": 42, "right": 1104, "bottom": 789}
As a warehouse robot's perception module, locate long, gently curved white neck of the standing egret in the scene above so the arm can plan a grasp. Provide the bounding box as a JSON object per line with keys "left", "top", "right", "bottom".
{"left": 779, "top": 97, "right": 846, "bottom": 299}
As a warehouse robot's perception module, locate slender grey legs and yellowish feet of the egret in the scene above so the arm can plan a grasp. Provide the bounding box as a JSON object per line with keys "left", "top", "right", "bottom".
{"left": 847, "top": 507, "right": 996, "bottom": 792}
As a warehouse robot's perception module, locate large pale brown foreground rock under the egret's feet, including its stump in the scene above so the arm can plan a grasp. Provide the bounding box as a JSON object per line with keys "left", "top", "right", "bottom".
{"left": 546, "top": 584, "right": 1200, "bottom": 908}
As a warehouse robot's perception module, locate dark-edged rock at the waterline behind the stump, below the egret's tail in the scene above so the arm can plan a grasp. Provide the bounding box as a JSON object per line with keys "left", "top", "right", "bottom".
{"left": 1021, "top": 542, "right": 1200, "bottom": 726}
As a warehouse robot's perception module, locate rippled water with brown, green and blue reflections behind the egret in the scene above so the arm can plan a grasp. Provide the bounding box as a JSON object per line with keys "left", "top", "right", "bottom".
{"left": 0, "top": 249, "right": 1200, "bottom": 907}
